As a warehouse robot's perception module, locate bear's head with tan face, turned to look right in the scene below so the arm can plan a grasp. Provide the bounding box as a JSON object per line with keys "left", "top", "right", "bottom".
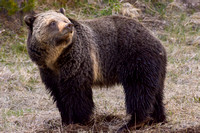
{"left": 24, "top": 8, "right": 74, "bottom": 68}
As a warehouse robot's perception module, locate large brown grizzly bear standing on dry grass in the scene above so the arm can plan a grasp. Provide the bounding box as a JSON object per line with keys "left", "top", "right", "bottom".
{"left": 25, "top": 9, "right": 167, "bottom": 130}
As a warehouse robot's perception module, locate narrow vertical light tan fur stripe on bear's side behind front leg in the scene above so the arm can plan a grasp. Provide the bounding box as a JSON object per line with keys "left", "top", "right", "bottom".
{"left": 90, "top": 46, "right": 103, "bottom": 82}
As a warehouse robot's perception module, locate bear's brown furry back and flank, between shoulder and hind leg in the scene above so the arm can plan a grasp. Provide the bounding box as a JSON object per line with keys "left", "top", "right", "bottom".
{"left": 68, "top": 16, "right": 165, "bottom": 85}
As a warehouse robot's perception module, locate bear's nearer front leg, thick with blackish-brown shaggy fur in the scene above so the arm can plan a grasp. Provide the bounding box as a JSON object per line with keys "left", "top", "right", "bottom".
{"left": 57, "top": 77, "right": 94, "bottom": 125}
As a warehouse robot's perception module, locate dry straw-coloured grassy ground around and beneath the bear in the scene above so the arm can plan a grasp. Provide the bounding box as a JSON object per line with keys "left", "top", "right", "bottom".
{"left": 0, "top": 0, "right": 200, "bottom": 132}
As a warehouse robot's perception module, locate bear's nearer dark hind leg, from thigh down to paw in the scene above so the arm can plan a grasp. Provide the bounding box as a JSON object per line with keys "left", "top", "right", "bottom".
{"left": 120, "top": 57, "right": 162, "bottom": 128}
